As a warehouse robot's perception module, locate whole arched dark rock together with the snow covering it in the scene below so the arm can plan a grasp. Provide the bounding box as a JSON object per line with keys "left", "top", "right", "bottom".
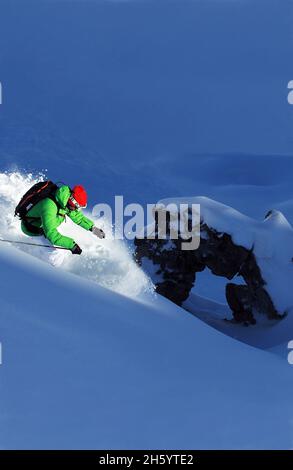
{"left": 135, "top": 197, "right": 293, "bottom": 324}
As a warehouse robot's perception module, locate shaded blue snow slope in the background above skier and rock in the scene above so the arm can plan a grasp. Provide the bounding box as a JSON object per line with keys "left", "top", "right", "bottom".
{"left": 0, "top": 0, "right": 293, "bottom": 209}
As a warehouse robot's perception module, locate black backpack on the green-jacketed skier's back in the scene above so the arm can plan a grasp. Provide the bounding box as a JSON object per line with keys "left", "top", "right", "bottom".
{"left": 14, "top": 180, "right": 58, "bottom": 220}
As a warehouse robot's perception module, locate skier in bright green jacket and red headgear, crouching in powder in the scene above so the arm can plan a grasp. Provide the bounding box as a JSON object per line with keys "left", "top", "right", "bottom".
{"left": 16, "top": 181, "right": 105, "bottom": 265}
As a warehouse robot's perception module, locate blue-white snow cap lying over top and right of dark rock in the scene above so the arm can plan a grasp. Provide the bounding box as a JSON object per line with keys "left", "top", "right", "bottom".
{"left": 158, "top": 197, "right": 293, "bottom": 313}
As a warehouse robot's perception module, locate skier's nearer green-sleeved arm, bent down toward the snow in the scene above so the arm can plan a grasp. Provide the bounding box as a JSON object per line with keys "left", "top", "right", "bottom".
{"left": 41, "top": 199, "right": 75, "bottom": 250}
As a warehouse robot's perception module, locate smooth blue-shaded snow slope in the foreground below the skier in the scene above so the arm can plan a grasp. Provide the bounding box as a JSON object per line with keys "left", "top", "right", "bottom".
{"left": 0, "top": 246, "right": 293, "bottom": 449}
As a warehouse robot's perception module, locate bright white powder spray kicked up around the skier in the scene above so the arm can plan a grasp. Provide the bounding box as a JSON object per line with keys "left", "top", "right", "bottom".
{"left": 0, "top": 172, "right": 153, "bottom": 297}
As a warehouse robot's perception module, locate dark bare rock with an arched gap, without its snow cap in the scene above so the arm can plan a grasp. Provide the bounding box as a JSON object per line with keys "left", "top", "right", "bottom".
{"left": 135, "top": 207, "right": 281, "bottom": 324}
